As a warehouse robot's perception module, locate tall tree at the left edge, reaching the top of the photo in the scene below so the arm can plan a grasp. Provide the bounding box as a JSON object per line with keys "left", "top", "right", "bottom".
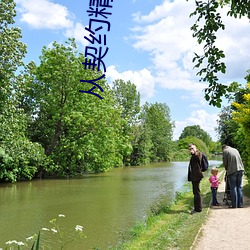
{"left": 0, "top": 0, "right": 26, "bottom": 108}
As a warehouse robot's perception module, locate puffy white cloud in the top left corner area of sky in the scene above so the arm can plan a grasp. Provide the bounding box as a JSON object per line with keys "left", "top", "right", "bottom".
{"left": 16, "top": 0, "right": 73, "bottom": 29}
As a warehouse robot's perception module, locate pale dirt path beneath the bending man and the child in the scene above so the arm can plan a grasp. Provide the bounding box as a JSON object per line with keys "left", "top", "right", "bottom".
{"left": 191, "top": 174, "right": 250, "bottom": 250}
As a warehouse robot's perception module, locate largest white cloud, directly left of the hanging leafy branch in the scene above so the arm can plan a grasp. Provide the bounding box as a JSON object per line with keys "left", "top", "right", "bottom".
{"left": 130, "top": 0, "right": 204, "bottom": 96}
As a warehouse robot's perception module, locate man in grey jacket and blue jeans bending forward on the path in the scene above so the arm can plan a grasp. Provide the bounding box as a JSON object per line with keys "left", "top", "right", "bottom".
{"left": 222, "top": 145, "right": 244, "bottom": 208}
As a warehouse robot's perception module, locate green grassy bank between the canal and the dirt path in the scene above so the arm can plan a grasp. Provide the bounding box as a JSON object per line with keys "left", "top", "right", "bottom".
{"left": 111, "top": 170, "right": 223, "bottom": 250}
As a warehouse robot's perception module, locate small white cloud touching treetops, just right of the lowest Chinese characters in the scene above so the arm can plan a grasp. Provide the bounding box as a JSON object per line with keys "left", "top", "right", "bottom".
{"left": 106, "top": 65, "right": 155, "bottom": 103}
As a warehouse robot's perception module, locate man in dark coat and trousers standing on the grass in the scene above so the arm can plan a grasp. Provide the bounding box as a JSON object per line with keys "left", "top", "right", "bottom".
{"left": 188, "top": 143, "right": 203, "bottom": 214}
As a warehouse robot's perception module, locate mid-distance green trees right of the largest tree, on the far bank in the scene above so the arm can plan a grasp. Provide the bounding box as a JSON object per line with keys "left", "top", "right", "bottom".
{"left": 112, "top": 80, "right": 173, "bottom": 165}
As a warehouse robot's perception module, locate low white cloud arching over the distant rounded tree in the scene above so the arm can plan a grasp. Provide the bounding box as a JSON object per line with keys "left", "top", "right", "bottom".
{"left": 173, "top": 109, "right": 218, "bottom": 141}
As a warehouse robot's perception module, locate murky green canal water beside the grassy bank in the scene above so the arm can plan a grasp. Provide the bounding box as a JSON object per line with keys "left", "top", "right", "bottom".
{"left": 0, "top": 160, "right": 221, "bottom": 250}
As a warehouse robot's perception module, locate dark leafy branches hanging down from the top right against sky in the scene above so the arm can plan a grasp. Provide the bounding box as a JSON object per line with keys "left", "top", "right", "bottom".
{"left": 190, "top": 0, "right": 250, "bottom": 107}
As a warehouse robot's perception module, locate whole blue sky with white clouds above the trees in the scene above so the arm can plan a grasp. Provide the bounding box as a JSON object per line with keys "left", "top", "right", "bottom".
{"left": 15, "top": 0, "right": 250, "bottom": 141}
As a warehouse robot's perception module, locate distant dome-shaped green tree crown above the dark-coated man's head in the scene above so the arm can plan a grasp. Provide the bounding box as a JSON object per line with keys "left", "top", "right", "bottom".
{"left": 179, "top": 125, "right": 212, "bottom": 147}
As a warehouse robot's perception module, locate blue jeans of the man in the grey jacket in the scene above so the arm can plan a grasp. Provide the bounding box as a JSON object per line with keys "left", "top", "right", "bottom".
{"left": 228, "top": 171, "right": 244, "bottom": 208}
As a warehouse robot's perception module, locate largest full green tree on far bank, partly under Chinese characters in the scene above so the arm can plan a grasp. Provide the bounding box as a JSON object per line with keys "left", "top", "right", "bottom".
{"left": 23, "top": 39, "right": 130, "bottom": 175}
